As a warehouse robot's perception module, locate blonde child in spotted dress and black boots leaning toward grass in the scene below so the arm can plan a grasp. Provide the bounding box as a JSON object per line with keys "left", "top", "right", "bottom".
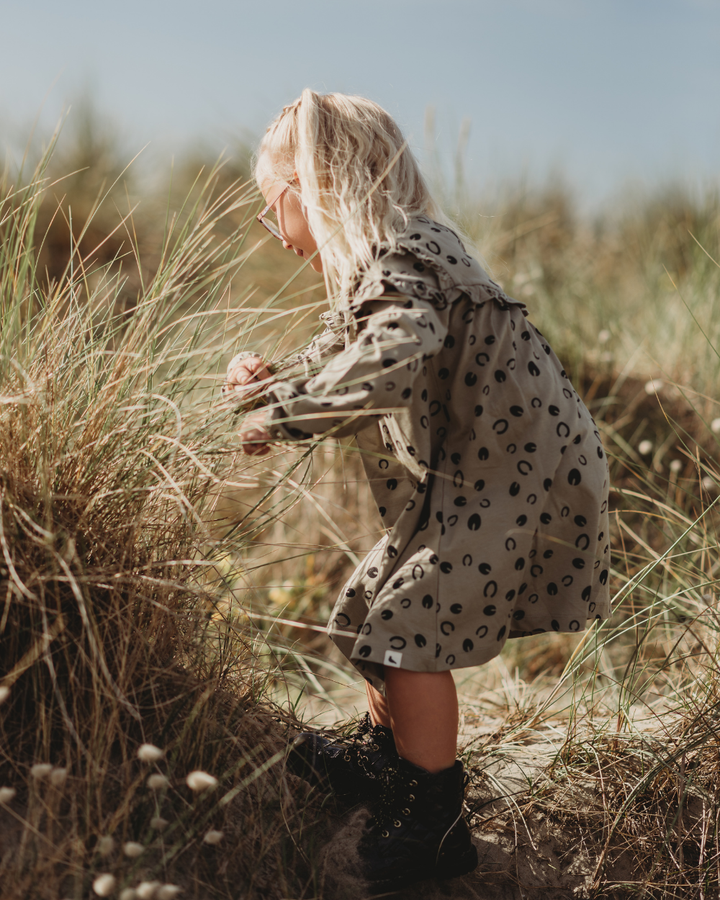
{"left": 223, "top": 90, "right": 609, "bottom": 890}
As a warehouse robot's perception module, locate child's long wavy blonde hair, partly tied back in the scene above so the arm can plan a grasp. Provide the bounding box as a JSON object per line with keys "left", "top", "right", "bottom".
{"left": 254, "top": 89, "right": 445, "bottom": 299}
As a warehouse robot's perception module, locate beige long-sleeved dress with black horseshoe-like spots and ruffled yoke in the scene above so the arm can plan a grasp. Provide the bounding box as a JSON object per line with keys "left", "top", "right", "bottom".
{"left": 256, "top": 216, "right": 610, "bottom": 690}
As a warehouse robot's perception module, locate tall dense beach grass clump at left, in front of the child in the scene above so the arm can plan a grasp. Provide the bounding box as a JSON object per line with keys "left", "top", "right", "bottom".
{"left": 0, "top": 141, "right": 334, "bottom": 900}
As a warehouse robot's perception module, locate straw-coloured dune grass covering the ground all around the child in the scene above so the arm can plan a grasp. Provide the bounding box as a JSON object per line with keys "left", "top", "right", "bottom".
{"left": 0, "top": 114, "right": 720, "bottom": 900}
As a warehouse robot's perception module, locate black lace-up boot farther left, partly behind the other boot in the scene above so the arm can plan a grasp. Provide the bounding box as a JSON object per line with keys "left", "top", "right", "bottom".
{"left": 287, "top": 715, "right": 398, "bottom": 806}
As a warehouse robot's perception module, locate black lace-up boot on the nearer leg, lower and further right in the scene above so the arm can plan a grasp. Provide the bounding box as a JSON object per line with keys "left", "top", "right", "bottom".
{"left": 359, "top": 757, "right": 478, "bottom": 891}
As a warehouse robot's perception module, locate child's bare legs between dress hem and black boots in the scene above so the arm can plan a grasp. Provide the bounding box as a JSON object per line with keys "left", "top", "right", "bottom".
{"left": 367, "top": 667, "right": 458, "bottom": 772}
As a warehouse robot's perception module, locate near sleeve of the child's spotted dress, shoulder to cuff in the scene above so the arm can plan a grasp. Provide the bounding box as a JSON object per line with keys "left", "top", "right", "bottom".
{"left": 266, "top": 295, "right": 447, "bottom": 440}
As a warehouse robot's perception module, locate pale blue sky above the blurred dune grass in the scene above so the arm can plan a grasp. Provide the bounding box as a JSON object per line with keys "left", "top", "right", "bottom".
{"left": 0, "top": 0, "right": 720, "bottom": 202}
